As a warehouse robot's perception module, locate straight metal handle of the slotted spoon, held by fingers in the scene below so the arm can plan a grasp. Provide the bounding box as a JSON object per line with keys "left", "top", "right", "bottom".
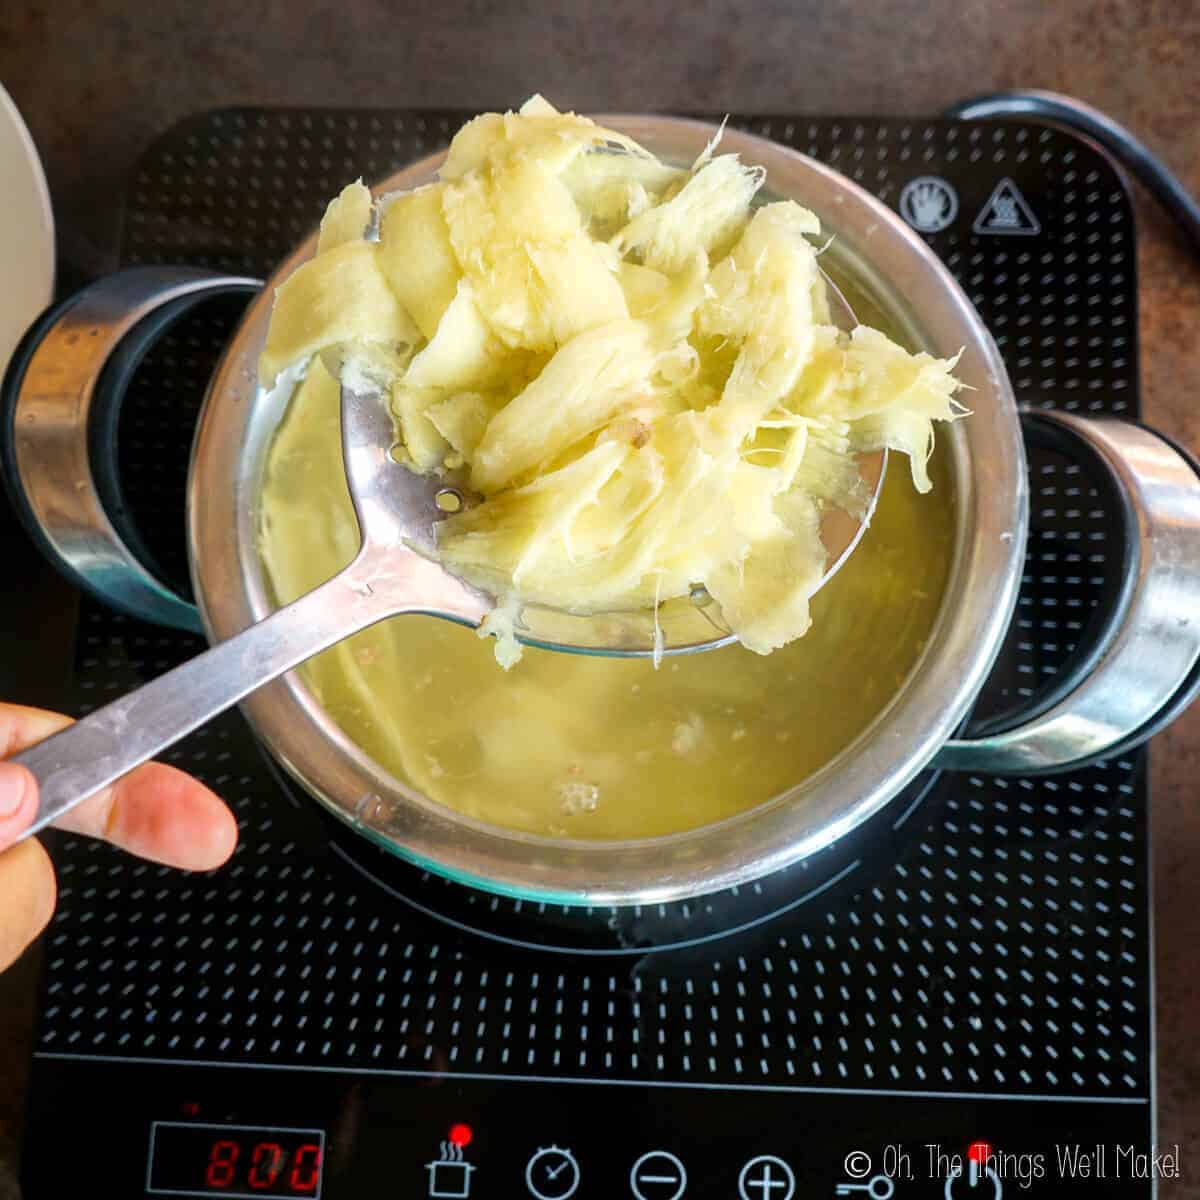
{"left": 11, "top": 557, "right": 406, "bottom": 838}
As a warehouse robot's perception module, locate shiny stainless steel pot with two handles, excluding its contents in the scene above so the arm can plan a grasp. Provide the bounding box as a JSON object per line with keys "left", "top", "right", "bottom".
{"left": 8, "top": 116, "right": 1200, "bottom": 904}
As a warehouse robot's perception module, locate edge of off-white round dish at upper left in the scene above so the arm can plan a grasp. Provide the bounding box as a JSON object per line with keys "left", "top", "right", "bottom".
{"left": 0, "top": 86, "right": 54, "bottom": 376}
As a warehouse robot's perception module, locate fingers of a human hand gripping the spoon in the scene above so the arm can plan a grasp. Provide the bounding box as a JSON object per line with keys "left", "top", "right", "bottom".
{"left": 0, "top": 704, "right": 238, "bottom": 971}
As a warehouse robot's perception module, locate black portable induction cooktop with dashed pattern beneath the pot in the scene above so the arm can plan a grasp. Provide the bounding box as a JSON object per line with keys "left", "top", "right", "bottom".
{"left": 11, "top": 109, "right": 1153, "bottom": 1200}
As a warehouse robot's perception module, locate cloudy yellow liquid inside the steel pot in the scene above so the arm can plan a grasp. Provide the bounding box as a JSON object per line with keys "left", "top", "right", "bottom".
{"left": 262, "top": 369, "right": 953, "bottom": 839}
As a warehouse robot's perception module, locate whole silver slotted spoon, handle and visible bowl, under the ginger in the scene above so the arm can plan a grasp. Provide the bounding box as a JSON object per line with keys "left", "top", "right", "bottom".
{"left": 11, "top": 278, "right": 887, "bottom": 838}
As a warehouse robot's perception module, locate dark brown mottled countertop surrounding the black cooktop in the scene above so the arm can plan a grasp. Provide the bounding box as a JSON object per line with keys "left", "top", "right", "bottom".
{"left": 0, "top": 0, "right": 1200, "bottom": 1200}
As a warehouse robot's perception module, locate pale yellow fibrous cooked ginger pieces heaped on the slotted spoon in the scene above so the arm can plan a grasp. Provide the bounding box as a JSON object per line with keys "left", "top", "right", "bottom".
{"left": 260, "top": 97, "right": 959, "bottom": 660}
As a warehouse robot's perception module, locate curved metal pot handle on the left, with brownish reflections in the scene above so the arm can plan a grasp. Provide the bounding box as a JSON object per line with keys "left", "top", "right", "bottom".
{"left": 0, "top": 266, "right": 262, "bottom": 634}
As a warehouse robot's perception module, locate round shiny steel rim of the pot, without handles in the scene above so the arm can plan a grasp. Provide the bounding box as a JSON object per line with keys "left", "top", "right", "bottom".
{"left": 187, "top": 114, "right": 1027, "bottom": 905}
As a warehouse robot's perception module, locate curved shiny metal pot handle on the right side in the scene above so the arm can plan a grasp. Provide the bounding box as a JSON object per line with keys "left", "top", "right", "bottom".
{"left": 936, "top": 410, "right": 1200, "bottom": 774}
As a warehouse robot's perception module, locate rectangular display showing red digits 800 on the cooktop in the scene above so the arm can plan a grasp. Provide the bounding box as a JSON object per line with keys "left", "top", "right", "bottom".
{"left": 148, "top": 1121, "right": 325, "bottom": 1198}
